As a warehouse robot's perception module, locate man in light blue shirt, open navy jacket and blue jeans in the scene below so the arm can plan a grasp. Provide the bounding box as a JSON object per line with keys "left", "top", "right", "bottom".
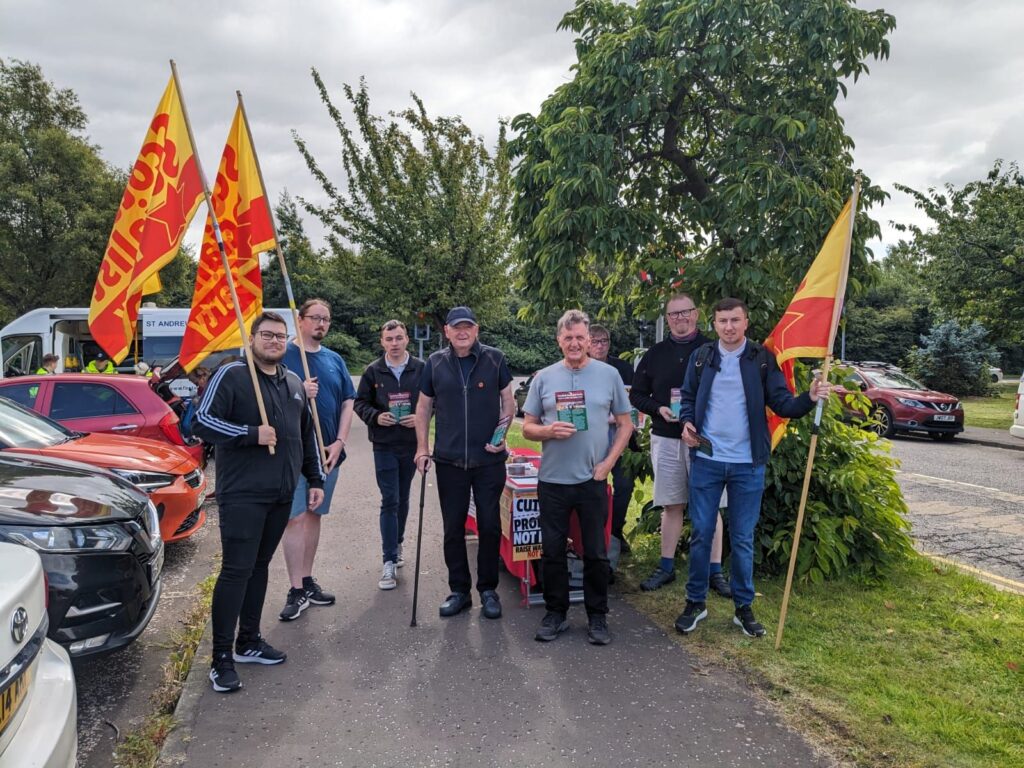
{"left": 676, "top": 299, "right": 831, "bottom": 637}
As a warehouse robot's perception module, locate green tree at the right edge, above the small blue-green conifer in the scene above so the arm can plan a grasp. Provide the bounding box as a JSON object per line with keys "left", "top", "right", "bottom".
{"left": 896, "top": 161, "right": 1024, "bottom": 362}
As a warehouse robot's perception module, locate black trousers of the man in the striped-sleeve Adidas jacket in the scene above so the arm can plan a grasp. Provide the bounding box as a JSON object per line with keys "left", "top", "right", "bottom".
{"left": 212, "top": 500, "right": 292, "bottom": 653}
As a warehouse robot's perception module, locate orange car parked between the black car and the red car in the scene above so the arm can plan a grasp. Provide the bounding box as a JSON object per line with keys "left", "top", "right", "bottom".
{"left": 0, "top": 397, "right": 206, "bottom": 542}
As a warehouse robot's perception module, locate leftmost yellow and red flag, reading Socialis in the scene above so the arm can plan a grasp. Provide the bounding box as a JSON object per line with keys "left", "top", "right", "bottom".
{"left": 89, "top": 77, "right": 203, "bottom": 362}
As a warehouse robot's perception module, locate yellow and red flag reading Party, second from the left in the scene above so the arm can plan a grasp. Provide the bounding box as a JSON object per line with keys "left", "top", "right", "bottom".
{"left": 178, "top": 106, "right": 275, "bottom": 371}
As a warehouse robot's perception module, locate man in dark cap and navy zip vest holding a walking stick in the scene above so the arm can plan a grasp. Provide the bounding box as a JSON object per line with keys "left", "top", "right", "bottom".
{"left": 416, "top": 306, "right": 515, "bottom": 618}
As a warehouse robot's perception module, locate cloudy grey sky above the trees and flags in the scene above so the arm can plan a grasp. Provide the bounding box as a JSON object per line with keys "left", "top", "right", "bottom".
{"left": 0, "top": 0, "right": 1024, "bottom": 262}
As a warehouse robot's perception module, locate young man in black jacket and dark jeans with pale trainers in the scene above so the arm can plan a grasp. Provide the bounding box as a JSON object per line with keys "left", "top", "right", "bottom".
{"left": 355, "top": 319, "right": 423, "bottom": 590}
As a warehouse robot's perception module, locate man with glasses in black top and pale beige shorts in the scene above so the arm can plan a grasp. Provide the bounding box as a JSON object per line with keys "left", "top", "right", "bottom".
{"left": 630, "top": 293, "right": 732, "bottom": 597}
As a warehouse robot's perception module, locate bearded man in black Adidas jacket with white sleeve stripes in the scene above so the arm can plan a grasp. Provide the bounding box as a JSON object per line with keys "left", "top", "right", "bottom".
{"left": 195, "top": 312, "right": 325, "bottom": 693}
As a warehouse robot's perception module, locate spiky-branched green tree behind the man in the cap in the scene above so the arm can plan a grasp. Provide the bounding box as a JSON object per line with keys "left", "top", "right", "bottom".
{"left": 294, "top": 70, "right": 510, "bottom": 328}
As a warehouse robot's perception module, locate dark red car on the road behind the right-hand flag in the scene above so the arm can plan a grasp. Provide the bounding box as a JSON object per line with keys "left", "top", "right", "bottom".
{"left": 841, "top": 361, "right": 964, "bottom": 440}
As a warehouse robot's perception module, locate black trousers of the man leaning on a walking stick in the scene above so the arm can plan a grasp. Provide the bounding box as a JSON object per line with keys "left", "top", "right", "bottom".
{"left": 434, "top": 462, "right": 505, "bottom": 593}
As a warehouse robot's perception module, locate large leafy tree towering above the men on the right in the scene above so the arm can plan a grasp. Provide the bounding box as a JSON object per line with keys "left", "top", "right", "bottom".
{"left": 510, "top": 0, "right": 895, "bottom": 332}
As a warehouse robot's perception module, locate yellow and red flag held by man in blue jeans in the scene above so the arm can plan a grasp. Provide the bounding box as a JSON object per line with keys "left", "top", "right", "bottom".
{"left": 765, "top": 190, "right": 857, "bottom": 449}
